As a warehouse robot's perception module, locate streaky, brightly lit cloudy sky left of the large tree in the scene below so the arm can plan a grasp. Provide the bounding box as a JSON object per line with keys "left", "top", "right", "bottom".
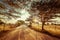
{"left": 0, "top": 1, "right": 31, "bottom": 23}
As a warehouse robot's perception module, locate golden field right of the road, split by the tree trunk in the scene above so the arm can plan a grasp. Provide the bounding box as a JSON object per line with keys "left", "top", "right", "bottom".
{"left": 31, "top": 23, "right": 60, "bottom": 37}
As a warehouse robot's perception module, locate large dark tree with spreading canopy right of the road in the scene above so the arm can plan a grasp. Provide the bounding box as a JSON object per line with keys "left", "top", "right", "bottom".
{"left": 31, "top": 0, "right": 60, "bottom": 30}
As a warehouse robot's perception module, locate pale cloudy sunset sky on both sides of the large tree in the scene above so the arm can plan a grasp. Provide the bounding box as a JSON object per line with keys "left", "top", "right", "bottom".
{"left": 0, "top": 0, "right": 60, "bottom": 24}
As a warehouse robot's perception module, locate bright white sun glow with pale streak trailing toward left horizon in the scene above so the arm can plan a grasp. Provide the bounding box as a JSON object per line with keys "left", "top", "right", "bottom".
{"left": 7, "top": 9, "right": 30, "bottom": 23}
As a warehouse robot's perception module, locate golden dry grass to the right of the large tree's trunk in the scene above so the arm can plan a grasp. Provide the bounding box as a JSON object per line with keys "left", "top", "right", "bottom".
{"left": 44, "top": 25, "right": 60, "bottom": 37}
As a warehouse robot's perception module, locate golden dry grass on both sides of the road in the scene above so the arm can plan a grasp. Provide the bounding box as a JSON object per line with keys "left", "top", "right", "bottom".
{"left": 0, "top": 23, "right": 60, "bottom": 37}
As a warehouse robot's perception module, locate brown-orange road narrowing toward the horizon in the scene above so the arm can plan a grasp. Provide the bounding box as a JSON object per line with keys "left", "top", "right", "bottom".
{"left": 0, "top": 26, "right": 60, "bottom": 40}
